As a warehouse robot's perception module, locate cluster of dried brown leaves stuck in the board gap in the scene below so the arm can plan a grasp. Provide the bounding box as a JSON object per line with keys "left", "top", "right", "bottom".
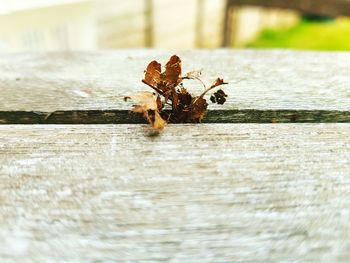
{"left": 124, "top": 55, "right": 227, "bottom": 129}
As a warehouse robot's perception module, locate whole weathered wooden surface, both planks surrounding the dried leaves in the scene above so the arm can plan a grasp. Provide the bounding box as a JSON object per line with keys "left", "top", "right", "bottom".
{"left": 0, "top": 50, "right": 350, "bottom": 262}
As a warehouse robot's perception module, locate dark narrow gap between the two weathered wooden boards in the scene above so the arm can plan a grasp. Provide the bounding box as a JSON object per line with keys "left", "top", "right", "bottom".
{"left": 0, "top": 109, "right": 350, "bottom": 124}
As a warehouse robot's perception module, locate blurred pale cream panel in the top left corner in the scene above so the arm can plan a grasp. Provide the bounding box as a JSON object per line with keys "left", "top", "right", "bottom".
{"left": 0, "top": 0, "right": 97, "bottom": 52}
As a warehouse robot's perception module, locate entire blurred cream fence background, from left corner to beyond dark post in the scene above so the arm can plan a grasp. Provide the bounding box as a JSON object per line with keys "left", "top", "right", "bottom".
{"left": 0, "top": 0, "right": 312, "bottom": 51}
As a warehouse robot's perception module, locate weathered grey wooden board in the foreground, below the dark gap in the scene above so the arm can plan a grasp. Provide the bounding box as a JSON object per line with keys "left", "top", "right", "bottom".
{"left": 0, "top": 124, "right": 350, "bottom": 263}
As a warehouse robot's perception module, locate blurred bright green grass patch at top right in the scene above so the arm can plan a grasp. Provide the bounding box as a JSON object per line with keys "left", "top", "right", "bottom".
{"left": 247, "top": 18, "right": 350, "bottom": 50}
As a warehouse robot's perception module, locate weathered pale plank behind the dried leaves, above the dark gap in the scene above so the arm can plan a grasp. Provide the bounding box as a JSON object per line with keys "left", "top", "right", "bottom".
{"left": 0, "top": 50, "right": 350, "bottom": 123}
